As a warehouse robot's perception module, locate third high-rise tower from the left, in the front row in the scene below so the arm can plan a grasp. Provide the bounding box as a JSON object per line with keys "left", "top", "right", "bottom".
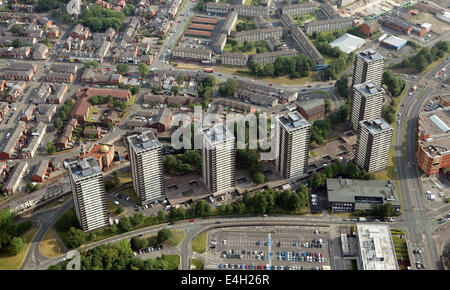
{"left": 202, "top": 124, "right": 236, "bottom": 195}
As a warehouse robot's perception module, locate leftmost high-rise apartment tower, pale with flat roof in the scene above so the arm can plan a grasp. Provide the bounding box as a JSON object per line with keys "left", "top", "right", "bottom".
{"left": 69, "top": 157, "right": 109, "bottom": 232}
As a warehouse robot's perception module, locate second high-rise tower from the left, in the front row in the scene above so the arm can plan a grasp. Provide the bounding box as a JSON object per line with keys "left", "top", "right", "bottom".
{"left": 127, "top": 131, "right": 166, "bottom": 204}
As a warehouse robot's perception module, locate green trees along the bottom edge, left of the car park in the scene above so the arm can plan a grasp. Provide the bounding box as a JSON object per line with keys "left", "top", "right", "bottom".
{"left": 49, "top": 240, "right": 168, "bottom": 270}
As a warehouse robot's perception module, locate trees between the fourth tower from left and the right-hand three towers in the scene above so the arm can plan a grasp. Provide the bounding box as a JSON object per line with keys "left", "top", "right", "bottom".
{"left": 311, "top": 104, "right": 350, "bottom": 145}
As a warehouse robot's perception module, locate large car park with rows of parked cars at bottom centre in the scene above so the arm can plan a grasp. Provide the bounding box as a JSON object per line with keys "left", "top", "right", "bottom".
{"left": 205, "top": 226, "right": 329, "bottom": 270}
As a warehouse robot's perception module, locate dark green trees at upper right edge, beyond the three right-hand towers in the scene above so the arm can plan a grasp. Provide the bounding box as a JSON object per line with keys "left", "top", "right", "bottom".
{"left": 397, "top": 40, "right": 450, "bottom": 72}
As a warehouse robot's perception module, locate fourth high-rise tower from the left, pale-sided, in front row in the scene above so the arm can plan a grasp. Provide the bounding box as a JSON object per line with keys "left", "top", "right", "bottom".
{"left": 275, "top": 112, "right": 311, "bottom": 179}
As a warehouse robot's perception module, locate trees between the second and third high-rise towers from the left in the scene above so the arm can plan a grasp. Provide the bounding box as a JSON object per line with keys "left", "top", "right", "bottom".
{"left": 163, "top": 150, "right": 202, "bottom": 175}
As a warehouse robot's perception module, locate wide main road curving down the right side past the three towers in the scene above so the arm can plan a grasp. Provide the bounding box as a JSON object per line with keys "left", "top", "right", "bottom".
{"left": 393, "top": 60, "right": 449, "bottom": 269}
